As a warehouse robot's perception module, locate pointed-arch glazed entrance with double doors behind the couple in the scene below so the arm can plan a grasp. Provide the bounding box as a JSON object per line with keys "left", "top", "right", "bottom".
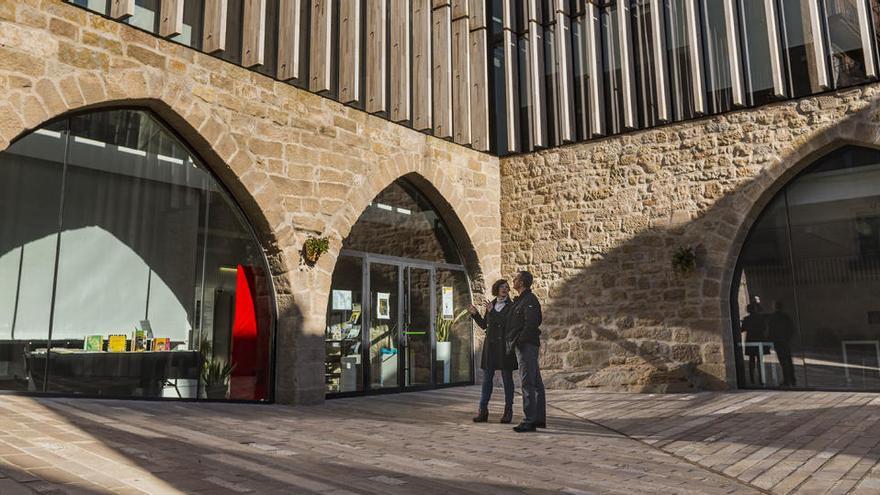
{"left": 325, "top": 179, "right": 474, "bottom": 394}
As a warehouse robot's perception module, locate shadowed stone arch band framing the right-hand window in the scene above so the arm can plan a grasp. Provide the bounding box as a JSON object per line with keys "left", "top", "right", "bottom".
{"left": 718, "top": 106, "right": 880, "bottom": 382}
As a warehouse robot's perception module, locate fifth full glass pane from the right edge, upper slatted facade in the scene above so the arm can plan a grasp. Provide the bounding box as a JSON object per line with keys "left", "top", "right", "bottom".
{"left": 666, "top": 0, "right": 699, "bottom": 120}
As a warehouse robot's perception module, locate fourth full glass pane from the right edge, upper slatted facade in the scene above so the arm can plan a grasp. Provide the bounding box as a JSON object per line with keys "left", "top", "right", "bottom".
{"left": 703, "top": 0, "right": 733, "bottom": 113}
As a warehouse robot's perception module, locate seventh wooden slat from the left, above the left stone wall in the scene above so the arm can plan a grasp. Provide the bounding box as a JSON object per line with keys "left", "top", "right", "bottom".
{"left": 339, "top": 1, "right": 361, "bottom": 103}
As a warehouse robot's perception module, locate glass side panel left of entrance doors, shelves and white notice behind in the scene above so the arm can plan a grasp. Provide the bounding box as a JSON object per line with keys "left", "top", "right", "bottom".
{"left": 324, "top": 256, "right": 364, "bottom": 393}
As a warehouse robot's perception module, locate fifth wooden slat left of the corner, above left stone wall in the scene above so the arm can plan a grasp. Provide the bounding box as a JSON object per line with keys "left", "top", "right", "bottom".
{"left": 390, "top": 0, "right": 411, "bottom": 122}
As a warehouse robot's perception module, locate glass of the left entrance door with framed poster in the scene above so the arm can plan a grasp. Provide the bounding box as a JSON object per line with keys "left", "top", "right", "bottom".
{"left": 370, "top": 263, "right": 400, "bottom": 389}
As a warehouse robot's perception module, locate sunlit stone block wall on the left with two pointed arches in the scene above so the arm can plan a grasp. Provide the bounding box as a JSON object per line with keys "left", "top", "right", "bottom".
{"left": 0, "top": 0, "right": 501, "bottom": 403}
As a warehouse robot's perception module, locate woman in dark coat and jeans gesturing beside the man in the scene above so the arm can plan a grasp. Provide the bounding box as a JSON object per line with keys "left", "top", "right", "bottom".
{"left": 468, "top": 279, "right": 517, "bottom": 423}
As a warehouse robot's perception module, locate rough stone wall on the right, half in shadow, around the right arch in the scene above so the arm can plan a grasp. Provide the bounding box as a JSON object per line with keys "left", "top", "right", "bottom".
{"left": 501, "top": 84, "right": 880, "bottom": 391}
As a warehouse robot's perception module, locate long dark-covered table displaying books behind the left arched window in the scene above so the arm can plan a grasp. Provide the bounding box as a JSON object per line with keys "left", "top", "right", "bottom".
{"left": 25, "top": 349, "right": 201, "bottom": 397}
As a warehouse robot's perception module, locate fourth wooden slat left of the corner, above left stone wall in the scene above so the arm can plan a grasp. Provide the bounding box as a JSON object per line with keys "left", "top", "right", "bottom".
{"left": 412, "top": 0, "right": 432, "bottom": 131}
